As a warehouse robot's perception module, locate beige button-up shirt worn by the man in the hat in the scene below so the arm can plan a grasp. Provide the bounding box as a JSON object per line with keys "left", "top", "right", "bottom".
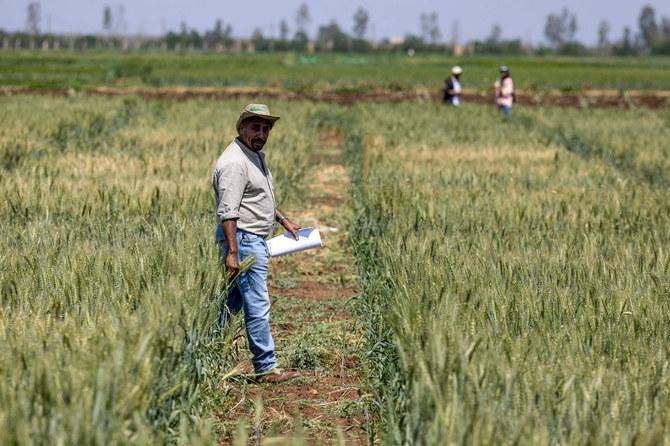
{"left": 212, "top": 139, "right": 275, "bottom": 238}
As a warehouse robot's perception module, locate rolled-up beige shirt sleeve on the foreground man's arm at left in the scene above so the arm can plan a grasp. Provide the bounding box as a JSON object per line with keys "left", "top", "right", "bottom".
{"left": 215, "top": 162, "right": 247, "bottom": 222}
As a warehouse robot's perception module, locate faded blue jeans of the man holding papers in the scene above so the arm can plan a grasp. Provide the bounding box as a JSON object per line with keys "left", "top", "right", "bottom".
{"left": 216, "top": 225, "right": 277, "bottom": 373}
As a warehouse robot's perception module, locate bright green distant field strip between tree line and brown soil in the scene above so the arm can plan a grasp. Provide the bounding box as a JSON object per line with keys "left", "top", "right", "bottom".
{"left": 0, "top": 51, "right": 670, "bottom": 93}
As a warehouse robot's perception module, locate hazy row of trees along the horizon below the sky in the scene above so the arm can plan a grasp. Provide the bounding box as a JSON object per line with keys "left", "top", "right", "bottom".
{"left": 5, "top": 2, "right": 670, "bottom": 56}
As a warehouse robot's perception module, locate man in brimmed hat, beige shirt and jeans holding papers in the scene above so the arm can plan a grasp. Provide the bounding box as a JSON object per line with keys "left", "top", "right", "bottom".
{"left": 212, "top": 104, "right": 301, "bottom": 383}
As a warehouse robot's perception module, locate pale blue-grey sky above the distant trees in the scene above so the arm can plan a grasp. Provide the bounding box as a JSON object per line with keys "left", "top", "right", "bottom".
{"left": 0, "top": 0, "right": 670, "bottom": 45}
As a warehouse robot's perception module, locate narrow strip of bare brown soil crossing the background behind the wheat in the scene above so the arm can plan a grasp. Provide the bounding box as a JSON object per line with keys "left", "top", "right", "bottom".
{"left": 6, "top": 87, "right": 670, "bottom": 109}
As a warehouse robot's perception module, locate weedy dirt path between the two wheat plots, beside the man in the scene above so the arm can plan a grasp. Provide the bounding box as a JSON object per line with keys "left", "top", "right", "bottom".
{"left": 220, "top": 133, "right": 367, "bottom": 444}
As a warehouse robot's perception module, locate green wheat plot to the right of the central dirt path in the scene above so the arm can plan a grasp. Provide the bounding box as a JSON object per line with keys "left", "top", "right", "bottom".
{"left": 351, "top": 104, "right": 670, "bottom": 444}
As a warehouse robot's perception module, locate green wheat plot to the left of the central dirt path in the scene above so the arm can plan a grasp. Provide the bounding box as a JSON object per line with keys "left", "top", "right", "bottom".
{"left": 0, "top": 96, "right": 322, "bottom": 444}
